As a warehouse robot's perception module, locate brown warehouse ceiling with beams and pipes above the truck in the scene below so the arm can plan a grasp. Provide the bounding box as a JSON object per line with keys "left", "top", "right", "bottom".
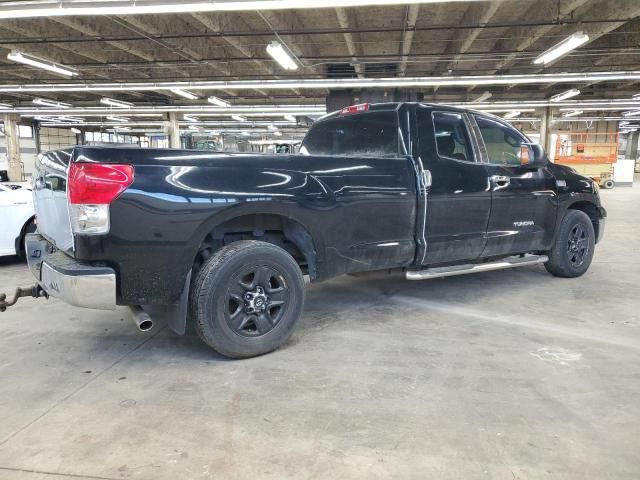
{"left": 0, "top": 0, "right": 640, "bottom": 131}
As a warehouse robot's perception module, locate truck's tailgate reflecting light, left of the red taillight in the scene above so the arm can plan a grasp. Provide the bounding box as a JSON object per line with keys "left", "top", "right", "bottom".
{"left": 33, "top": 149, "right": 73, "bottom": 254}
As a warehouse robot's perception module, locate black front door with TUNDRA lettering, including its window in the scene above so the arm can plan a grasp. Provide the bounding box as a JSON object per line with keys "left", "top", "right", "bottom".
{"left": 475, "top": 115, "right": 556, "bottom": 257}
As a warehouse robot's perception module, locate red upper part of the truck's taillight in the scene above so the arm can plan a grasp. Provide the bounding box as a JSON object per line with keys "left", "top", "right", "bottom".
{"left": 69, "top": 163, "right": 133, "bottom": 205}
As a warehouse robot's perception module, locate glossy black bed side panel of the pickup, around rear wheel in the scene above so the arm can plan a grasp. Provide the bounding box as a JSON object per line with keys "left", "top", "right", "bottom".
{"left": 75, "top": 150, "right": 416, "bottom": 304}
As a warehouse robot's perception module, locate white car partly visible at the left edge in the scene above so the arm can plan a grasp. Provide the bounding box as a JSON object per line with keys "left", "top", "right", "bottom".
{"left": 0, "top": 183, "right": 36, "bottom": 257}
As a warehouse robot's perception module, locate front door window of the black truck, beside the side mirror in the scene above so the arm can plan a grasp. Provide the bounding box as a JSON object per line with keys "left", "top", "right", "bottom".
{"left": 476, "top": 116, "right": 526, "bottom": 166}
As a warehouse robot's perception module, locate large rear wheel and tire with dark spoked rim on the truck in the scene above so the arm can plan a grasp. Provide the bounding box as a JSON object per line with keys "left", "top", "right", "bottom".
{"left": 190, "top": 240, "right": 305, "bottom": 358}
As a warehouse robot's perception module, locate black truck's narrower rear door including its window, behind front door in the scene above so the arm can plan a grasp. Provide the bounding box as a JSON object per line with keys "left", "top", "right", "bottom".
{"left": 417, "top": 108, "right": 491, "bottom": 265}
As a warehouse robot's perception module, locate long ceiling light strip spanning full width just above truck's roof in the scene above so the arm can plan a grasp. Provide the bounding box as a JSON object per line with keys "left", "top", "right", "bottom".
{"left": 0, "top": 70, "right": 640, "bottom": 94}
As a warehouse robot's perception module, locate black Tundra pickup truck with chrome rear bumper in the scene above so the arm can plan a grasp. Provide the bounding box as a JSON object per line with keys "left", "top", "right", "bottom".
{"left": 6, "top": 103, "right": 606, "bottom": 358}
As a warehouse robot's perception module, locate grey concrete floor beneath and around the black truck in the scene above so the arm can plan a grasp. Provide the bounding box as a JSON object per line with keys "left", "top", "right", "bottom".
{"left": 0, "top": 184, "right": 640, "bottom": 480}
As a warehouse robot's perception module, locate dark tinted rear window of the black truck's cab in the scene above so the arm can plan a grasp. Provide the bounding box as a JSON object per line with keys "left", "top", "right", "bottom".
{"left": 300, "top": 112, "right": 398, "bottom": 157}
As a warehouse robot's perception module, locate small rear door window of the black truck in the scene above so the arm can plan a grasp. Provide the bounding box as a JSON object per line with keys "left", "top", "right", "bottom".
{"left": 432, "top": 112, "right": 474, "bottom": 162}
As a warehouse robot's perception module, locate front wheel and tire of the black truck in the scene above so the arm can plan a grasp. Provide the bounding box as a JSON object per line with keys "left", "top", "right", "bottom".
{"left": 544, "top": 210, "right": 596, "bottom": 278}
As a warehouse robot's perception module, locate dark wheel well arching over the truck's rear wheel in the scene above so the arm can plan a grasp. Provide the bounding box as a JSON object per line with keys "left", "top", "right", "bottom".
{"left": 193, "top": 214, "right": 317, "bottom": 279}
